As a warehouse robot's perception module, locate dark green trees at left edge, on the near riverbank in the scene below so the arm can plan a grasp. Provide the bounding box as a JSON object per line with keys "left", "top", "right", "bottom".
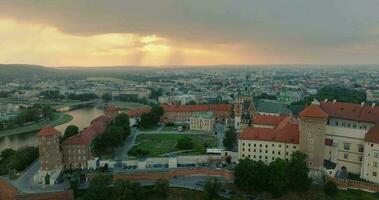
{"left": 0, "top": 147, "right": 38, "bottom": 175}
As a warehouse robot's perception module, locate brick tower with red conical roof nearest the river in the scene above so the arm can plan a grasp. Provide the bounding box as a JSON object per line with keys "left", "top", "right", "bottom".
{"left": 37, "top": 126, "right": 62, "bottom": 184}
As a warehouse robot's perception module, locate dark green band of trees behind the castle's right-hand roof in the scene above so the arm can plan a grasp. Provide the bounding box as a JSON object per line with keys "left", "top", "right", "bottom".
{"left": 289, "top": 86, "right": 366, "bottom": 114}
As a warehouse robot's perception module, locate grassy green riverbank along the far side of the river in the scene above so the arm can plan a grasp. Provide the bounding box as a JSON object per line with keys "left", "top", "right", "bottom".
{"left": 0, "top": 113, "right": 73, "bottom": 138}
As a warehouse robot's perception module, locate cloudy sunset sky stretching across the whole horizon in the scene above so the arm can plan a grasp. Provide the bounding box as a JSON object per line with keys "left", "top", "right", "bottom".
{"left": 0, "top": 0, "right": 379, "bottom": 67}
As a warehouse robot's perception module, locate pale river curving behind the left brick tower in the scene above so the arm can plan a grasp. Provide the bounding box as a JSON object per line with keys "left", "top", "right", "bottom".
{"left": 0, "top": 107, "right": 103, "bottom": 152}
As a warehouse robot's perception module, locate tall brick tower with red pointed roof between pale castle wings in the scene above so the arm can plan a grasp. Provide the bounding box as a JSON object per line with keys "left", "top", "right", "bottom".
{"left": 299, "top": 100, "right": 328, "bottom": 178}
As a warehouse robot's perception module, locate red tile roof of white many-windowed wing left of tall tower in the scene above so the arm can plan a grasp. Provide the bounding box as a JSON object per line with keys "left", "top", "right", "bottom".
{"left": 238, "top": 118, "right": 300, "bottom": 144}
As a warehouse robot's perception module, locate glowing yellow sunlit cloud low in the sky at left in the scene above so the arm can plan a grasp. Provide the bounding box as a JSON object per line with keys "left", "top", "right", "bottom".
{"left": 0, "top": 19, "right": 251, "bottom": 66}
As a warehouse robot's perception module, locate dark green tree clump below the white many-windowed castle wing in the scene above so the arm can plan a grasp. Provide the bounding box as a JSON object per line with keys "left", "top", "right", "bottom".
{"left": 235, "top": 152, "right": 312, "bottom": 197}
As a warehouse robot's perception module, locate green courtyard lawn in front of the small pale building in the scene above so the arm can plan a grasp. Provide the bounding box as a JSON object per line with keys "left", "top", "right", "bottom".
{"left": 130, "top": 134, "right": 217, "bottom": 156}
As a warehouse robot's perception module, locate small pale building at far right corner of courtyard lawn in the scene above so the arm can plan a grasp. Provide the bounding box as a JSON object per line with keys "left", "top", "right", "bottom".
{"left": 190, "top": 112, "right": 215, "bottom": 132}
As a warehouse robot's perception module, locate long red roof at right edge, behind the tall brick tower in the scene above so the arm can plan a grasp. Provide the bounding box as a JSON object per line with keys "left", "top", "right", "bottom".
{"left": 320, "top": 102, "right": 379, "bottom": 123}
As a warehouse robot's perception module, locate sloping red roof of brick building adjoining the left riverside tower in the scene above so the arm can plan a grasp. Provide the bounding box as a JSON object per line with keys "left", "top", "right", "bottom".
{"left": 63, "top": 115, "right": 112, "bottom": 145}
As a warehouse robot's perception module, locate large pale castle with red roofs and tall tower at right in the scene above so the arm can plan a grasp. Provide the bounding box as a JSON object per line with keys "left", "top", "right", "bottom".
{"left": 238, "top": 100, "right": 379, "bottom": 183}
